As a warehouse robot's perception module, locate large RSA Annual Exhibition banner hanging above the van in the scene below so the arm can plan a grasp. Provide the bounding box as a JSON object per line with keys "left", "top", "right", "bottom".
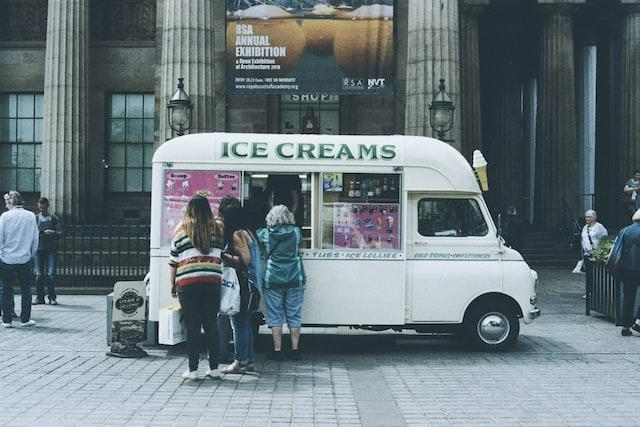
{"left": 226, "top": 0, "right": 395, "bottom": 95}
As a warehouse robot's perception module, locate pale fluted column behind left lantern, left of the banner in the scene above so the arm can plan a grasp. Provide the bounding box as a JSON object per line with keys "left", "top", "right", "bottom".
{"left": 159, "top": 0, "right": 224, "bottom": 143}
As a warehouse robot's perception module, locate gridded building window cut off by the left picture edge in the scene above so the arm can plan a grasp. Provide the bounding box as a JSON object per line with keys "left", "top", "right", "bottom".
{"left": 0, "top": 93, "right": 44, "bottom": 193}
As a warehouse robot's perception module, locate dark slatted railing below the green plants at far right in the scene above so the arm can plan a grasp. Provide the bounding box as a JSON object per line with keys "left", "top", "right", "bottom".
{"left": 585, "top": 262, "right": 622, "bottom": 326}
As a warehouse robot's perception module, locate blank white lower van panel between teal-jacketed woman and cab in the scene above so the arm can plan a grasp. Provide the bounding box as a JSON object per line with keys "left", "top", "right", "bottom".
{"left": 302, "top": 259, "right": 405, "bottom": 325}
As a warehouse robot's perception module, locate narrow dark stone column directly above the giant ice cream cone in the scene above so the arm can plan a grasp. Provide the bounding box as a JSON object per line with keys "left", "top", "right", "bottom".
{"left": 460, "top": 0, "right": 489, "bottom": 159}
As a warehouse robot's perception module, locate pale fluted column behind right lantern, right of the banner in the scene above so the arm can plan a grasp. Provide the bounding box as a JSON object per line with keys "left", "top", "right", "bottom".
{"left": 405, "top": 0, "right": 461, "bottom": 150}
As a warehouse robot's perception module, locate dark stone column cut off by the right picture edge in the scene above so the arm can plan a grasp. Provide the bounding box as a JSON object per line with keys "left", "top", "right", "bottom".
{"left": 620, "top": 0, "right": 640, "bottom": 177}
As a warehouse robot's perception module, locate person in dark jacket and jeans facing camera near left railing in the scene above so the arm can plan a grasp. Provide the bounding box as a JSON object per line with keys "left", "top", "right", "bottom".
{"left": 33, "top": 197, "right": 62, "bottom": 305}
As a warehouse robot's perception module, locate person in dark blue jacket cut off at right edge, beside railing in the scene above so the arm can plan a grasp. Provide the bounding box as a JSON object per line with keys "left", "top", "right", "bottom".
{"left": 612, "top": 209, "right": 640, "bottom": 336}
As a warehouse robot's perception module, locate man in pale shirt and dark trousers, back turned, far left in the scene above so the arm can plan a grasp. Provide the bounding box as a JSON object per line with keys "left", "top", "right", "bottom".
{"left": 0, "top": 191, "right": 39, "bottom": 328}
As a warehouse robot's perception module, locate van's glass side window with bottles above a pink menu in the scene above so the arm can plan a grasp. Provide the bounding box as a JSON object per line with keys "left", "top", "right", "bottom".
{"left": 321, "top": 173, "right": 401, "bottom": 251}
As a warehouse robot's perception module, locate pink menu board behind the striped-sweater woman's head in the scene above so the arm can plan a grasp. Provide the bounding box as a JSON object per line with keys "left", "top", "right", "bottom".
{"left": 162, "top": 170, "right": 241, "bottom": 244}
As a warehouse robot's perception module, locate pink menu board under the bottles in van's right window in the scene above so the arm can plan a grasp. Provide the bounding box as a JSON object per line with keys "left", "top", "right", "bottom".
{"left": 333, "top": 203, "right": 400, "bottom": 250}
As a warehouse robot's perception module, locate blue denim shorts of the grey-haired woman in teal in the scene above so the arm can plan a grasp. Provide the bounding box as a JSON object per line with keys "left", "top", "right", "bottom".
{"left": 263, "top": 287, "right": 304, "bottom": 328}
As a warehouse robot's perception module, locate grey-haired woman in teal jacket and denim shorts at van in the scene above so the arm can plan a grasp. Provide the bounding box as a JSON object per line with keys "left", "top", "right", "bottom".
{"left": 257, "top": 205, "right": 306, "bottom": 360}
